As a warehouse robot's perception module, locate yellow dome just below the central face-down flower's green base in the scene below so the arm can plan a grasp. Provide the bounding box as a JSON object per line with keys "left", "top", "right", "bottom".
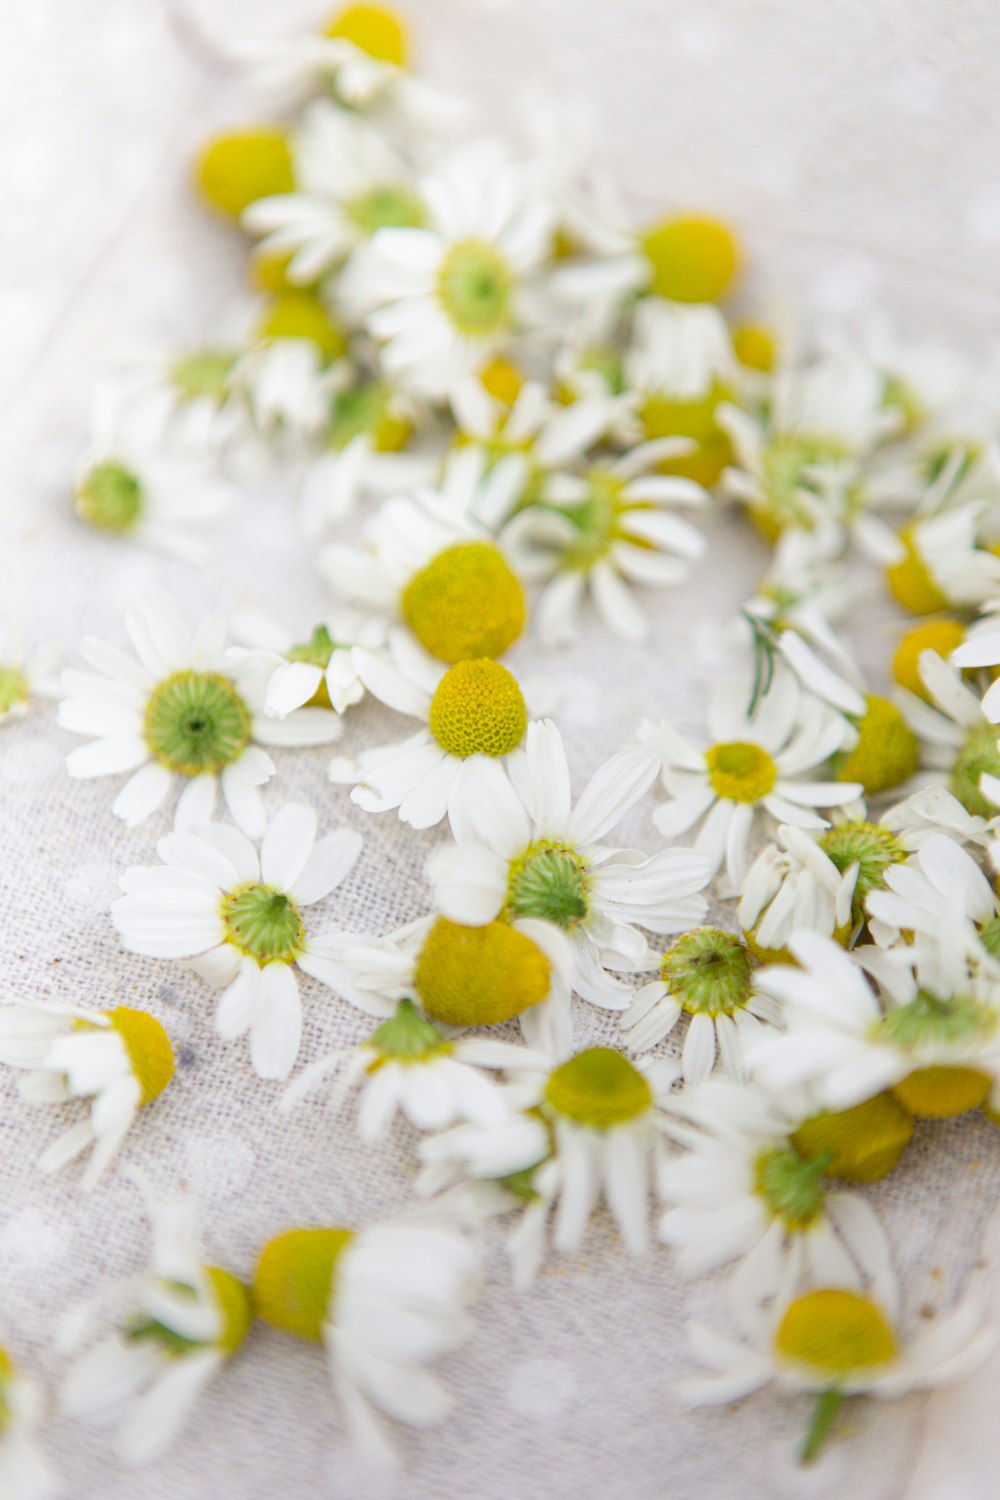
{"left": 414, "top": 917, "right": 552, "bottom": 1026}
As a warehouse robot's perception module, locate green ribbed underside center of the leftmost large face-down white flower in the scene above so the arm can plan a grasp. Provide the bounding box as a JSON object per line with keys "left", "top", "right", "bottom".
{"left": 142, "top": 672, "right": 250, "bottom": 776}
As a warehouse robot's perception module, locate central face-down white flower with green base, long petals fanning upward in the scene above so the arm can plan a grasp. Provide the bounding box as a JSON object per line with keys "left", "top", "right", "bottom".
{"left": 427, "top": 720, "right": 709, "bottom": 1010}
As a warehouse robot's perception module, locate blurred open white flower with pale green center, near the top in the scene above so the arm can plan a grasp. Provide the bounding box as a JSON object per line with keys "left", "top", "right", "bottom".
{"left": 345, "top": 140, "right": 555, "bottom": 398}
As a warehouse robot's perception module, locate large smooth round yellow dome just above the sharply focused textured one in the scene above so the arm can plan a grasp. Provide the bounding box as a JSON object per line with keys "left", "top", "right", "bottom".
{"left": 400, "top": 542, "right": 528, "bottom": 662}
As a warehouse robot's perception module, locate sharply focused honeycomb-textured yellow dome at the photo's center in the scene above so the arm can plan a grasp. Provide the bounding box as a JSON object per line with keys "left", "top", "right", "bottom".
{"left": 430, "top": 660, "right": 528, "bottom": 761}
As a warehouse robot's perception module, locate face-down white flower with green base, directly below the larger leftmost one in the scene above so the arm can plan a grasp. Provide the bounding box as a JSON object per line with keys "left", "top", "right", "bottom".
{"left": 111, "top": 803, "right": 361, "bottom": 1079}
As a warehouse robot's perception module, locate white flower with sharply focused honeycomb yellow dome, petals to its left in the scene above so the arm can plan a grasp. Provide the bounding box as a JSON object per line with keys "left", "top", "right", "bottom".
{"left": 330, "top": 632, "right": 539, "bottom": 828}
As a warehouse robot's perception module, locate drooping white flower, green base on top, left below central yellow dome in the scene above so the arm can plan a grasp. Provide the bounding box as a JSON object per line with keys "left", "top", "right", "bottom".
{"left": 280, "top": 1001, "right": 507, "bottom": 1142}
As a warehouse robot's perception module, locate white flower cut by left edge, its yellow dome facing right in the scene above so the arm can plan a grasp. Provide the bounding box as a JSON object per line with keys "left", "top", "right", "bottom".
{"left": 0, "top": 1005, "right": 174, "bottom": 1191}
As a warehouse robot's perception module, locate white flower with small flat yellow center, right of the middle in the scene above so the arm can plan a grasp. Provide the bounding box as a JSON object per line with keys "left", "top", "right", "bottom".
{"left": 640, "top": 672, "right": 862, "bottom": 891}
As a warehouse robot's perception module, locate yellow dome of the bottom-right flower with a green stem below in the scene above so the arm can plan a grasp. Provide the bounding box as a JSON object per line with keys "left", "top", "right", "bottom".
{"left": 774, "top": 1289, "right": 897, "bottom": 1379}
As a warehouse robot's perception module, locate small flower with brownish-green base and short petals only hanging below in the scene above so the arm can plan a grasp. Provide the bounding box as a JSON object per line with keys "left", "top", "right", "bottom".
{"left": 622, "top": 927, "right": 777, "bottom": 1083}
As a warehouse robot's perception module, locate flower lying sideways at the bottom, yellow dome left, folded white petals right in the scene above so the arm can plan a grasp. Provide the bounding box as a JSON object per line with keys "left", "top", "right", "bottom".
{"left": 253, "top": 1214, "right": 478, "bottom": 1460}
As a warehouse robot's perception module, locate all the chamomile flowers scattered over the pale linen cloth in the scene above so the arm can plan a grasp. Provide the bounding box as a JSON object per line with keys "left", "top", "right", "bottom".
{"left": 0, "top": 5, "right": 1000, "bottom": 1476}
